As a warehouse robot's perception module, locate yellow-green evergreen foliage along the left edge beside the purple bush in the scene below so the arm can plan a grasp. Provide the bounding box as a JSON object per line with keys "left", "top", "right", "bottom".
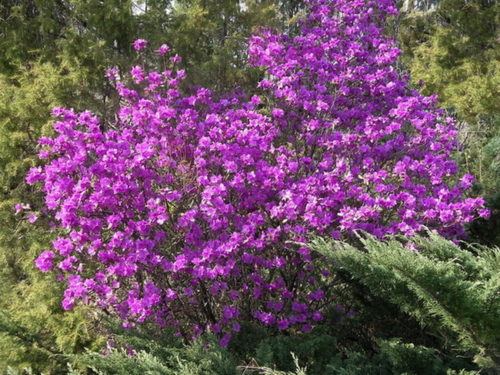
{"left": 0, "top": 63, "right": 106, "bottom": 371}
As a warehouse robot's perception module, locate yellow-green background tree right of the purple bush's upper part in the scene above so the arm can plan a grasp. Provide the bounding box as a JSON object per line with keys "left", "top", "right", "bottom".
{"left": 398, "top": 0, "right": 500, "bottom": 245}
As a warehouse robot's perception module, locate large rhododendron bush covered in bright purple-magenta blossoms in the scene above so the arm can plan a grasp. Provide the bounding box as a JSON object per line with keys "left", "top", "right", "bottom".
{"left": 27, "top": 0, "right": 487, "bottom": 344}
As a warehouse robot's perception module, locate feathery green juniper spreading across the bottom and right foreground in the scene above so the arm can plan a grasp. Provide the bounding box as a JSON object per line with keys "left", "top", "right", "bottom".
{"left": 16, "top": 233, "right": 492, "bottom": 375}
